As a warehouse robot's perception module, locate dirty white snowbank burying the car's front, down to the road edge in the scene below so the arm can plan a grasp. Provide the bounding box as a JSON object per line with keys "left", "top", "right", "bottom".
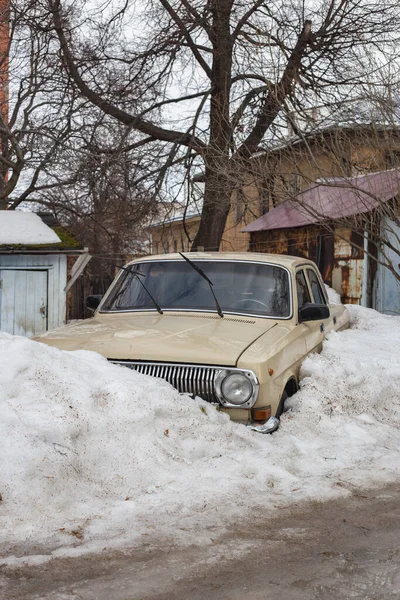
{"left": 0, "top": 307, "right": 400, "bottom": 566}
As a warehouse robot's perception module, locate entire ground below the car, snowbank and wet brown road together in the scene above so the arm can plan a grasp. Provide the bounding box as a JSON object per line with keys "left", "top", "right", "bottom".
{"left": 0, "top": 300, "right": 400, "bottom": 600}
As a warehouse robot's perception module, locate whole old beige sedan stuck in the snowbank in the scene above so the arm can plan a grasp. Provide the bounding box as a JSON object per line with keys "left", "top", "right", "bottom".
{"left": 38, "top": 252, "right": 349, "bottom": 432}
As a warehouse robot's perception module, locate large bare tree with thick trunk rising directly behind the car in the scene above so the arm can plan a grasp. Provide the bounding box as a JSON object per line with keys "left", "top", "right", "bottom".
{"left": 38, "top": 0, "right": 399, "bottom": 249}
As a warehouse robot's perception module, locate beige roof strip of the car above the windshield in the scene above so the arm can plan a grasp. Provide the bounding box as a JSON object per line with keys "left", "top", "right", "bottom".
{"left": 129, "top": 252, "right": 314, "bottom": 269}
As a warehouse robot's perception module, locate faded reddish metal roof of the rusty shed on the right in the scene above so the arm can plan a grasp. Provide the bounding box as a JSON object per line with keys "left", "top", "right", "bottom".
{"left": 242, "top": 169, "right": 400, "bottom": 232}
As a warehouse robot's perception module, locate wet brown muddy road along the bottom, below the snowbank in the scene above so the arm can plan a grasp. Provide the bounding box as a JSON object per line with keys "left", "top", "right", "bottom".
{"left": 0, "top": 485, "right": 400, "bottom": 600}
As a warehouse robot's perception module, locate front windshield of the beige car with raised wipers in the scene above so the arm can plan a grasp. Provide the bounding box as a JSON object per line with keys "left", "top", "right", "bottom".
{"left": 102, "top": 259, "right": 291, "bottom": 318}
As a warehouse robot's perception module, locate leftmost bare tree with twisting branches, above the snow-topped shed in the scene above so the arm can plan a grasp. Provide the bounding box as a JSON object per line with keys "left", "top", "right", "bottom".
{"left": 0, "top": 0, "right": 93, "bottom": 210}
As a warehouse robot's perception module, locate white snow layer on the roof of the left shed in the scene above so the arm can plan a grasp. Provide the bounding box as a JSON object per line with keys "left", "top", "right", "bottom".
{"left": 0, "top": 210, "right": 61, "bottom": 246}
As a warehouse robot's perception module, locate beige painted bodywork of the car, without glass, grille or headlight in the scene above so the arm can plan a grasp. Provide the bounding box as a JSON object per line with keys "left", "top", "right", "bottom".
{"left": 37, "top": 253, "right": 349, "bottom": 422}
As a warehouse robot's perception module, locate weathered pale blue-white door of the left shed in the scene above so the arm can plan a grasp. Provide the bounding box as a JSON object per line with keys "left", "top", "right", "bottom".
{"left": 0, "top": 269, "right": 47, "bottom": 337}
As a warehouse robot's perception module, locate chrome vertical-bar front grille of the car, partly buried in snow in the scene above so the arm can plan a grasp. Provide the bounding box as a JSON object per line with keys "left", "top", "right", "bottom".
{"left": 111, "top": 360, "right": 223, "bottom": 403}
